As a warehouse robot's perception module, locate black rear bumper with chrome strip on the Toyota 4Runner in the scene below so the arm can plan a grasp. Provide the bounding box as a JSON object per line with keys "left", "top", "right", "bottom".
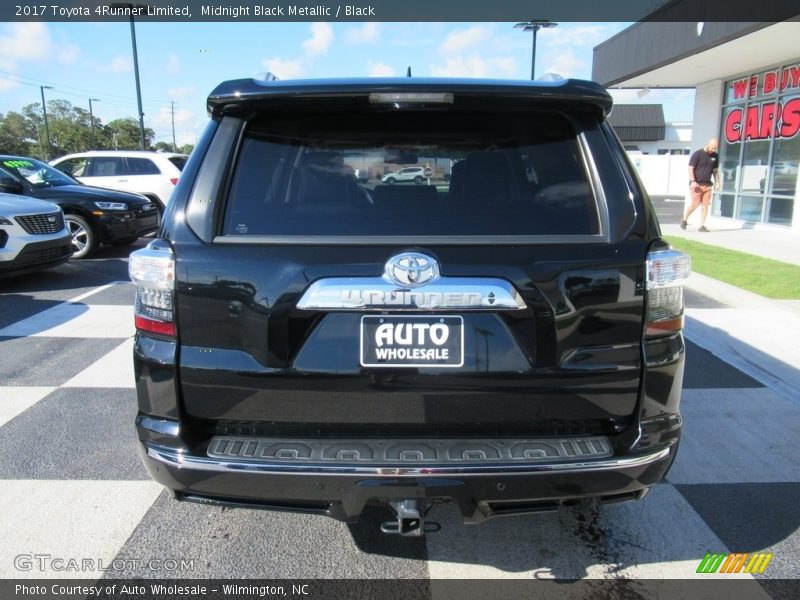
{"left": 138, "top": 418, "right": 677, "bottom": 522}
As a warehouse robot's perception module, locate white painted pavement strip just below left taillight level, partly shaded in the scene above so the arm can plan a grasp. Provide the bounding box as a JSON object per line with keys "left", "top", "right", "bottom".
{"left": 0, "top": 302, "right": 135, "bottom": 338}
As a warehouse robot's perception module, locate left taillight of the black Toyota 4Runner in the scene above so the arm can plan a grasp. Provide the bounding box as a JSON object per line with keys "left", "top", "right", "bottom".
{"left": 128, "top": 240, "right": 175, "bottom": 336}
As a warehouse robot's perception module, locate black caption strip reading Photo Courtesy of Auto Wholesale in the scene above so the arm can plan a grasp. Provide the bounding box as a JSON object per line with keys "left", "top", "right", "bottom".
{"left": 0, "top": 576, "right": 800, "bottom": 600}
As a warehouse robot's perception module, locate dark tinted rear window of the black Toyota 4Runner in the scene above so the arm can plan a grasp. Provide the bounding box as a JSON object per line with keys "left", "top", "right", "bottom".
{"left": 222, "top": 111, "right": 599, "bottom": 237}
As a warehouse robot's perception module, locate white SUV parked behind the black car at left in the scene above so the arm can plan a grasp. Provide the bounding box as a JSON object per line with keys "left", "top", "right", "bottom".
{"left": 50, "top": 150, "right": 188, "bottom": 214}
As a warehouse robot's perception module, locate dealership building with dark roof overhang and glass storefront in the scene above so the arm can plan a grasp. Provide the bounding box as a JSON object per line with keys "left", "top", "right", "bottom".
{"left": 592, "top": 21, "right": 800, "bottom": 233}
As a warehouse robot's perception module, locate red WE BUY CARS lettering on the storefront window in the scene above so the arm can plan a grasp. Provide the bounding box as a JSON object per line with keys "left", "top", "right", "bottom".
{"left": 725, "top": 63, "right": 800, "bottom": 144}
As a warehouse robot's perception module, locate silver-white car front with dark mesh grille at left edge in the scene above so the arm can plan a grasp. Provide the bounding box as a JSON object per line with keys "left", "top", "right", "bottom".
{"left": 0, "top": 193, "right": 72, "bottom": 277}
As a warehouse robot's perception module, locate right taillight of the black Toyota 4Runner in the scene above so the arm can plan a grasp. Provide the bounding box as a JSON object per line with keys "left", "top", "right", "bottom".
{"left": 645, "top": 249, "right": 692, "bottom": 337}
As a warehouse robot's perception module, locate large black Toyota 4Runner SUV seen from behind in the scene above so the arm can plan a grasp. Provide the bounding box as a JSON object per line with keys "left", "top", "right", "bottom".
{"left": 130, "top": 78, "right": 690, "bottom": 535}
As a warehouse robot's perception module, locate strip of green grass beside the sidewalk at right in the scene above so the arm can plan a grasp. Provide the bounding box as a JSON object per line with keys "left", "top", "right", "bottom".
{"left": 666, "top": 237, "right": 800, "bottom": 300}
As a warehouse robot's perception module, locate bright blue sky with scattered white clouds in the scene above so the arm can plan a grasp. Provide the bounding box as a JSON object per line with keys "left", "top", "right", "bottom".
{"left": 0, "top": 22, "right": 694, "bottom": 145}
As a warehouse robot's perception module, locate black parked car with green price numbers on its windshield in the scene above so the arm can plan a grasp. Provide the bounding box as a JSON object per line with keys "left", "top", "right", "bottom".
{"left": 0, "top": 156, "right": 159, "bottom": 258}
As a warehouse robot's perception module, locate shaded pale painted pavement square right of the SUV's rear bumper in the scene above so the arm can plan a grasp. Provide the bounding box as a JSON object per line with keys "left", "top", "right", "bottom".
{"left": 669, "top": 386, "right": 800, "bottom": 484}
